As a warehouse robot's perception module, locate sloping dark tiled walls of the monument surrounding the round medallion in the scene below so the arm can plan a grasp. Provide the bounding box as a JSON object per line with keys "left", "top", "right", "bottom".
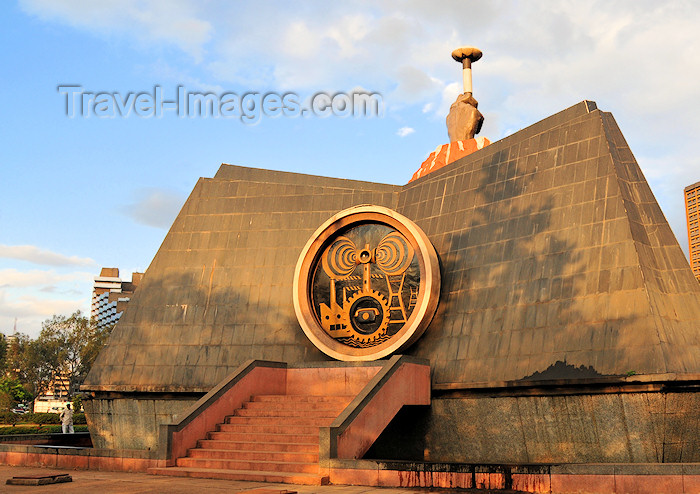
{"left": 85, "top": 102, "right": 700, "bottom": 392}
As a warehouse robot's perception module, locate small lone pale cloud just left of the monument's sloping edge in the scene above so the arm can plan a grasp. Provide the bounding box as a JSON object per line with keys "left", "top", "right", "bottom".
{"left": 122, "top": 188, "right": 185, "bottom": 229}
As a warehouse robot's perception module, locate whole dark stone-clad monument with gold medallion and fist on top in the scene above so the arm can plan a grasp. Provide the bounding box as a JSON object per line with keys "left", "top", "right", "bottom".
{"left": 84, "top": 45, "right": 700, "bottom": 481}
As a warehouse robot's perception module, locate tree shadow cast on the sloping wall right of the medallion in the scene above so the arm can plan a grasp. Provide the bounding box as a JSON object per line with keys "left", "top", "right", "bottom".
{"left": 415, "top": 141, "right": 614, "bottom": 384}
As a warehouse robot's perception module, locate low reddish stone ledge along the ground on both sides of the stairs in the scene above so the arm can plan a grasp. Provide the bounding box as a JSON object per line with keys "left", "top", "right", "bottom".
{"left": 0, "top": 444, "right": 700, "bottom": 494}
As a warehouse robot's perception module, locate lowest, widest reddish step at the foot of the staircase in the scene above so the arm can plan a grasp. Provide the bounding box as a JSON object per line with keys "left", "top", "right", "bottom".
{"left": 148, "top": 467, "right": 328, "bottom": 485}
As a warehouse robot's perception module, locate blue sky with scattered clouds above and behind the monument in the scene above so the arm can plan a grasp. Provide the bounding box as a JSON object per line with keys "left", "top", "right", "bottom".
{"left": 0, "top": 0, "right": 700, "bottom": 336}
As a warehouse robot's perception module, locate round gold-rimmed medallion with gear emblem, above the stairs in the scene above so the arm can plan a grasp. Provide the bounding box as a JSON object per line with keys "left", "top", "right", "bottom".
{"left": 294, "top": 206, "right": 440, "bottom": 361}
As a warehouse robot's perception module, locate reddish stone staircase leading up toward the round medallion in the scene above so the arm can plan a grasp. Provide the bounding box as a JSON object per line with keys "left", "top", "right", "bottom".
{"left": 149, "top": 395, "right": 354, "bottom": 485}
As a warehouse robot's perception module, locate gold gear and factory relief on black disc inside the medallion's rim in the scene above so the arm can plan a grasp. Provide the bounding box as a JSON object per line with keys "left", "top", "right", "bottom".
{"left": 311, "top": 224, "right": 420, "bottom": 348}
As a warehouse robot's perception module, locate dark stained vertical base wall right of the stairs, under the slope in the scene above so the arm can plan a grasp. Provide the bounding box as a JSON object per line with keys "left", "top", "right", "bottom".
{"left": 365, "top": 390, "right": 700, "bottom": 463}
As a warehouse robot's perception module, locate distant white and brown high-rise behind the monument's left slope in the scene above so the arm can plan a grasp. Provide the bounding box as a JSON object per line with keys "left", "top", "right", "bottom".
{"left": 90, "top": 268, "right": 143, "bottom": 328}
